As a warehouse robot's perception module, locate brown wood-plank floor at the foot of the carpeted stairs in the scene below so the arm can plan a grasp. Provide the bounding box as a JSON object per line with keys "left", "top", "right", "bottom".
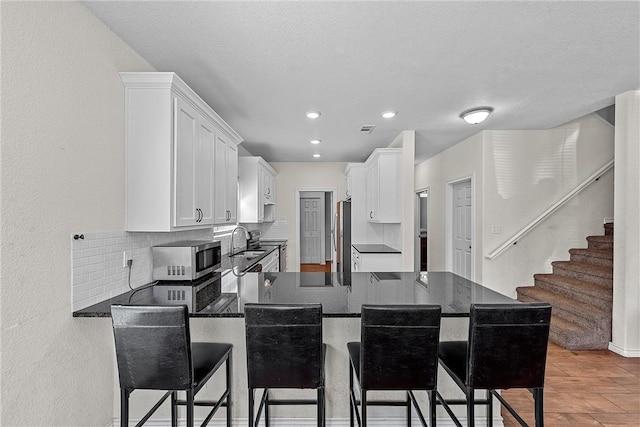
{"left": 502, "top": 343, "right": 640, "bottom": 427}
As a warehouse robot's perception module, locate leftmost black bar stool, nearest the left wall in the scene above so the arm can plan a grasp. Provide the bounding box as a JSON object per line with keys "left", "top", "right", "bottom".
{"left": 111, "top": 305, "right": 232, "bottom": 427}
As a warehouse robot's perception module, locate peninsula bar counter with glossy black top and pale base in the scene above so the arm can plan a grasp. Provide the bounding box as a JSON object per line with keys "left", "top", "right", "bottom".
{"left": 73, "top": 270, "right": 514, "bottom": 427}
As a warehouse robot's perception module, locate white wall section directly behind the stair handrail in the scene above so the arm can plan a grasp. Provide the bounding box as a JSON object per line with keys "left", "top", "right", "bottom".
{"left": 482, "top": 114, "right": 613, "bottom": 298}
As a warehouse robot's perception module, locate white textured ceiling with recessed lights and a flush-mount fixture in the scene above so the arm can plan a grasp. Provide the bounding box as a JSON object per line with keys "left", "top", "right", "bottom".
{"left": 86, "top": 1, "right": 640, "bottom": 162}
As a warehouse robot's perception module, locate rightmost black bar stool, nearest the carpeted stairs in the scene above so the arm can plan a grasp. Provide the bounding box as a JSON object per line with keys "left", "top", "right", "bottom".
{"left": 438, "top": 303, "right": 551, "bottom": 427}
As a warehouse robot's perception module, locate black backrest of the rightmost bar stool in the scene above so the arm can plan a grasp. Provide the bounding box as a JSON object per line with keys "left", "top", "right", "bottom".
{"left": 466, "top": 303, "right": 551, "bottom": 389}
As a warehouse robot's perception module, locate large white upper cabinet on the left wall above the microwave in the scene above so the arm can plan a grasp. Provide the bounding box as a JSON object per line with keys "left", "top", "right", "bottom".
{"left": 120, "top": 73, "right": 242, "bottom": 231}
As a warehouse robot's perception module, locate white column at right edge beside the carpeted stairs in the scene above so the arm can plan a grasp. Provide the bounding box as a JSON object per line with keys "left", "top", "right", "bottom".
{"left": 609, "top": 90, "right": 640, "bottom": 357}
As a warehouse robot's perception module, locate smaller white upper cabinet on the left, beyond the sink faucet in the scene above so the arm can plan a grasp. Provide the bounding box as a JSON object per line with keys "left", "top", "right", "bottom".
{"left": 239, "top": 156, "right": 276, "bottom": 223}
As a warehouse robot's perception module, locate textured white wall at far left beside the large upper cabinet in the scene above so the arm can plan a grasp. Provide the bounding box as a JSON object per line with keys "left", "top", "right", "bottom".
{"left": 0, "top": 2, "right": 153, "bottom": 426}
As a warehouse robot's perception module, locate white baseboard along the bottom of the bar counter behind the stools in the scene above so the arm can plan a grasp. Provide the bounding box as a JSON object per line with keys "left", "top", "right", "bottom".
{"left": 107, "top": 417, "right": 503, "bottom": 427}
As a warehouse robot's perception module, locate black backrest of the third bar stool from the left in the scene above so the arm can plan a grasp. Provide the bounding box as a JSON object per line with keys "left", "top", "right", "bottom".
{"left": 360, "top": 305, "right": 441, "bottom": 390}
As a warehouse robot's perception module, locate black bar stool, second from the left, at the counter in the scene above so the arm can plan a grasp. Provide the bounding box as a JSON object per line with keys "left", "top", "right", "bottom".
{"left": 244, "top": 304, "right": 325, "bottom": 427}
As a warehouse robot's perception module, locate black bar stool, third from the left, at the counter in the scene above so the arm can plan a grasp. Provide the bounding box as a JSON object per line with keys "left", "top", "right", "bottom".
{"left": 347, "top": 305, "right": 441, "bottom": 427}
